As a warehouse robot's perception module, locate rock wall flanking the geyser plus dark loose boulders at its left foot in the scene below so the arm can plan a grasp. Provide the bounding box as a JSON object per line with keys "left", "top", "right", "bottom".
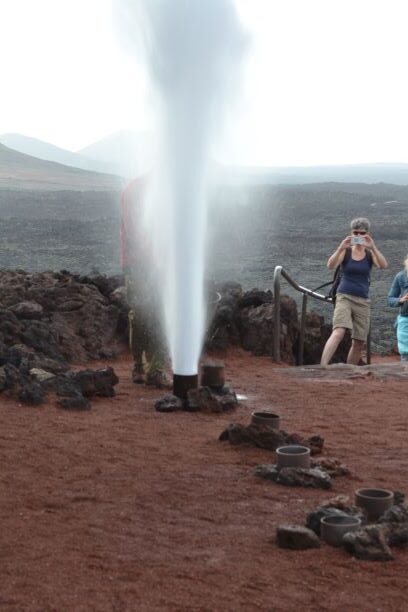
{"left": 0, "top": 270, "right": 346, "bottom": 409}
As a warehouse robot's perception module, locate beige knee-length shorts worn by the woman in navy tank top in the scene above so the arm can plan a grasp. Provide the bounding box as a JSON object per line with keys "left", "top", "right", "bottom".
{"left": 333, "top": 293, "right": 370, "bottom": 342}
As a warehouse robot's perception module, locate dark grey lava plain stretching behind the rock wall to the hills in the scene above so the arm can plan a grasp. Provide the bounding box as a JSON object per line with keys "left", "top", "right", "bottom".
{"left": 0, "top": 183, "right": 408, "bottom": 352}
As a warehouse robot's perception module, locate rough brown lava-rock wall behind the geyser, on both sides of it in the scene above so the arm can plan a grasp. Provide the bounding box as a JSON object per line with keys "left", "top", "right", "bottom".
{"left": 0, "top": 270, "right": 345, "bottom": 372}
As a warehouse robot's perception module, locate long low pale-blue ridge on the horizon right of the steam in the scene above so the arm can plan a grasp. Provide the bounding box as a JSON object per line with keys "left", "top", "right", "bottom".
{"left": 222, "top": 163, "right": 408, "bottom": 185}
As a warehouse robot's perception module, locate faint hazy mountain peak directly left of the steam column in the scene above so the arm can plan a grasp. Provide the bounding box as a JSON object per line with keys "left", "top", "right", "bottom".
{"left": 77, "top": 130, "right": 154, "bottom": 178}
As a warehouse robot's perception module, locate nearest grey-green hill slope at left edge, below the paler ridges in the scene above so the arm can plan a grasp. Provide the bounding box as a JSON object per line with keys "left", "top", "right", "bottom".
{"left": 0, "top": 144, "right": 123, "bottom": 191}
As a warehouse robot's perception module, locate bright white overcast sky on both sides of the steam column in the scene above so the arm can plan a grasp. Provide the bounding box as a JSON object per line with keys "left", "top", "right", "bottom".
{"left": 0, "top": 0, "right": 408, "bottom": 166}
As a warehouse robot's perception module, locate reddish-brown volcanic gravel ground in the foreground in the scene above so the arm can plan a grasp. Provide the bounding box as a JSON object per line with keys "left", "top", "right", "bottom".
{"left": 0, "top": 351, "right": 408, "bottom": 612}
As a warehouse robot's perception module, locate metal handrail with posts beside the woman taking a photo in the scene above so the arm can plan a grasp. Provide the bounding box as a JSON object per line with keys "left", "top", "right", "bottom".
{"left": 272, "top": 266, "right": 371, "bottom": 365}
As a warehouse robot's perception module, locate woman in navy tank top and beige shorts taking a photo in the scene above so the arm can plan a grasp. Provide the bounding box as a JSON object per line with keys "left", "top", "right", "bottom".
{"left": 321, "top": 218, "right": 388, "bottom": 366}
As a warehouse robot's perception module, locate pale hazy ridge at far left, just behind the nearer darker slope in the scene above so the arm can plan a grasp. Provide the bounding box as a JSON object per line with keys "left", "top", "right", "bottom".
{"left": 0, "top": 133, "right": 112, "bottom": 174}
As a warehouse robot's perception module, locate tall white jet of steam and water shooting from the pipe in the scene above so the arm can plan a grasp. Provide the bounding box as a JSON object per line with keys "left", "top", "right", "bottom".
{"left": 116, "top": 0, "right": 245, "bottom": 386}
